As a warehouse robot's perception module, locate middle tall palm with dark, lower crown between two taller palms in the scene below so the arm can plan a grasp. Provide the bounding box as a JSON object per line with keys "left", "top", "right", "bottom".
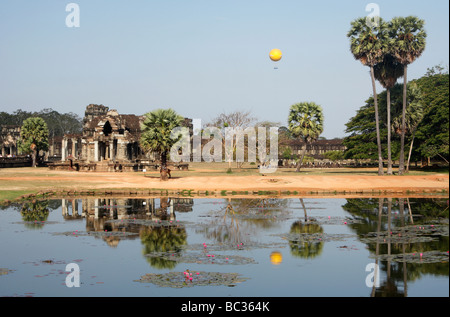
{"left": 374, "top": 54, "right": 403, "bottom": 175}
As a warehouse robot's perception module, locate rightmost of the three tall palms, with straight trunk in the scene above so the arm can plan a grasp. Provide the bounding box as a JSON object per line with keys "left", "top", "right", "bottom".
{"left": 389, "top": 16, "right": 427, "bottom": 175}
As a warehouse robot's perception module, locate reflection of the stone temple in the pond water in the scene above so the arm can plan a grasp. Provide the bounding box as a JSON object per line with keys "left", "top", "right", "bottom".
{"left": 61, "top": 197, "right": 194, "bottom": 246}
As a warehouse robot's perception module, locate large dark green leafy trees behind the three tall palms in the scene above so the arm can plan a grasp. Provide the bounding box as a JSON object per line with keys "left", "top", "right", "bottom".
{"left": 343, "top": 73, "right": 449, "bottom": 168}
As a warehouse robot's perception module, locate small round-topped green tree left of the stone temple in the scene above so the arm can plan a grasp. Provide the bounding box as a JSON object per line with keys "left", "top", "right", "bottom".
{"left": 19, "top": 117, "right": 48, "bottom": 167}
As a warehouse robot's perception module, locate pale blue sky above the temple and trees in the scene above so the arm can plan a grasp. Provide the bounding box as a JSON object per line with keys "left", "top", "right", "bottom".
{"left": 0, "top": 0, "right": 449, "bottom": 138}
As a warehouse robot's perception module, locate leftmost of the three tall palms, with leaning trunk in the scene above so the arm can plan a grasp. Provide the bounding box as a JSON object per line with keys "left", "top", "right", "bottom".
{"left": 347, "top": 18, "right": 389, "bottom": 175}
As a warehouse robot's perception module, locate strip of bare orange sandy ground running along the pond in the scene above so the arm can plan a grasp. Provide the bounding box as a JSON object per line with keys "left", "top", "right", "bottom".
{"left": 0, "top": 167, "right": 449, "bottom": 194}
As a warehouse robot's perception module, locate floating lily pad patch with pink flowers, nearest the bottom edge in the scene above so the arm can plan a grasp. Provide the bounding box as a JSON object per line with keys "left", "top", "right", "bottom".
{"left": 135, "top": 271, "right": 248, "bottom": 288}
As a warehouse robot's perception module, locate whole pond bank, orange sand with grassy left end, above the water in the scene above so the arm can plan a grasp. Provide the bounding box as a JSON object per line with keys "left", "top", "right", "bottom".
{"left": 0, "top": 168, "right": 449, "bottom": 201}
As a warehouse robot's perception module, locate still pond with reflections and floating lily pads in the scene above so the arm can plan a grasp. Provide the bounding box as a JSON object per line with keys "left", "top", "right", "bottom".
{"left": 0, "top": 197, "right": 449, "bottom": 297}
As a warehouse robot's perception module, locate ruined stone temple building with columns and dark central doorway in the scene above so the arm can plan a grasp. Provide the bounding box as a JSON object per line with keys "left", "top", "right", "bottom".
{"left": 50, "top": 104, "right": 192, "bottom": 171}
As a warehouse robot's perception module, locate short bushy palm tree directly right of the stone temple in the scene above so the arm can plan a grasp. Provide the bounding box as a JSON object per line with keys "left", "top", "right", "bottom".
{"left": 140, "top": 109, "right": 184, "bottom": 180}
